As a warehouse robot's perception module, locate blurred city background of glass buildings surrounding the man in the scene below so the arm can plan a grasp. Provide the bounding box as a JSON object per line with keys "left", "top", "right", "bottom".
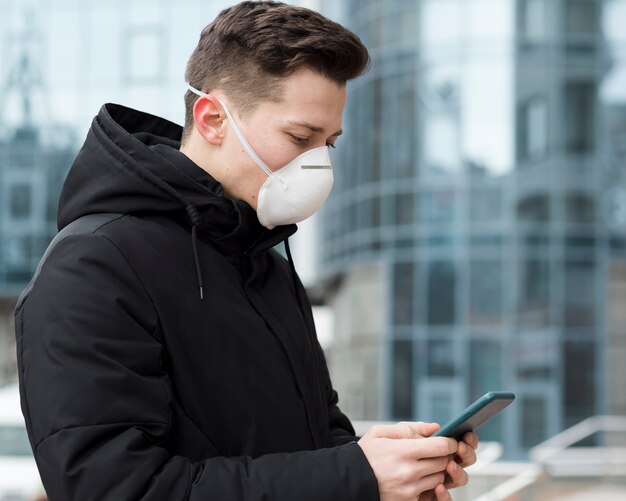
{"left": 0, "top": 0, "right": 626, "bottom": 500}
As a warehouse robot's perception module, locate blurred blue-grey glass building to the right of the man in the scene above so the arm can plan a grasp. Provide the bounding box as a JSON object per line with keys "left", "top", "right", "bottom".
{"left": 320, "top": 0, "right": 626, "bottom": 457}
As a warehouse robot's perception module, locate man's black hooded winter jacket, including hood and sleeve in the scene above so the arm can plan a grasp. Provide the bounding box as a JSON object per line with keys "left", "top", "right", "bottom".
{"left": 15, "top": 104, "right": 378, "bottom": 501}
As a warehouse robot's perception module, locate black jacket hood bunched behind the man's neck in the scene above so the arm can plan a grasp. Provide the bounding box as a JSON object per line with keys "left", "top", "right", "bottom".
{"left": 58, "top": 104, "right": 296, "bottom": 251}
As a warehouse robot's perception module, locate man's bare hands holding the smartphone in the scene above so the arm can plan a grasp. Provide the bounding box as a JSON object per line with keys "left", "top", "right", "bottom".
{"left": 359, "top": 423, "right": 456, "bottom": 501}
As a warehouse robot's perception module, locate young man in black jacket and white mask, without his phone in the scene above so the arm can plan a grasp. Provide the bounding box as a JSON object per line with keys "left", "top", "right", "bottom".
{"left": 16, "top": 2, "right": 477, "bottom": 501}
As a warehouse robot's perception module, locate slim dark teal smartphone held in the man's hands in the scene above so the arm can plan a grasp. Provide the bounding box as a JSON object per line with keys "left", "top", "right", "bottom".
{"left": 433, "top": 391, "right": 515, "bottom": 440}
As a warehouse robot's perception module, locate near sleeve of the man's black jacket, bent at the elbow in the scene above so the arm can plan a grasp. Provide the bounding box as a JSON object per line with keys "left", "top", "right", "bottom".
{"left": 16, "top": 234, "right": 378, "bottom": 501}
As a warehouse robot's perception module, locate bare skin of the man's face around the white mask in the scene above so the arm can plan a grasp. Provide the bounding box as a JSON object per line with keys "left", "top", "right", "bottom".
{"left": 223, "top": 69, "right": 346, "bottom": 209}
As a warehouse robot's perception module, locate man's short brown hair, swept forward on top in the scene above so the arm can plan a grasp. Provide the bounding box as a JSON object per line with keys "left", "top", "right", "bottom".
{"left": 183, "top": 1, "right": 370, "bottom": 139}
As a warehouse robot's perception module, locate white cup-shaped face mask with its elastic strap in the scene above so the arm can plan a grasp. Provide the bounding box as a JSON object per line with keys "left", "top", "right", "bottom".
{"left": 188, "top": 85, "right": 333, "bottom": 230}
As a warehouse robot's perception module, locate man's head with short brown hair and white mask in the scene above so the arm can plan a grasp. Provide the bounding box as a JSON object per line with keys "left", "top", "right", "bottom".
{"left": 180, "top": 2, "right": 369, "bottom": 218}
